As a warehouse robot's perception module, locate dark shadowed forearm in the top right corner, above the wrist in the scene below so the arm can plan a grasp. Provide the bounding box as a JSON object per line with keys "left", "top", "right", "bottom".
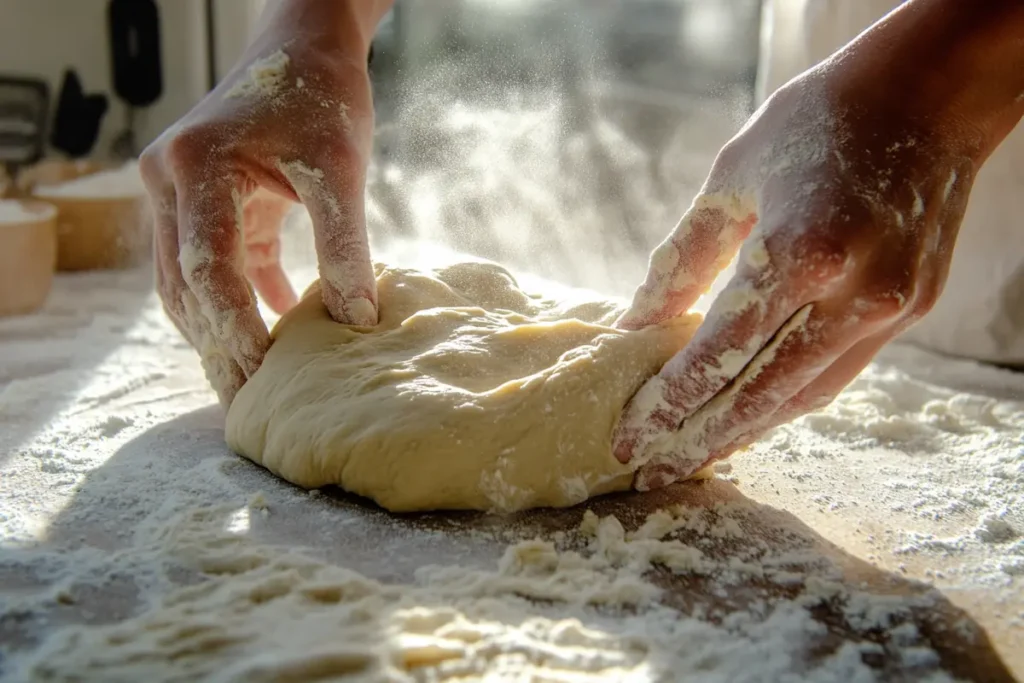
{"left": 837, "top": 0, "right": 1024, "bottom": 163}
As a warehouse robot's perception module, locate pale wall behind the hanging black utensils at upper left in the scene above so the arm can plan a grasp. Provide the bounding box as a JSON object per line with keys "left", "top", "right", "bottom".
{"left": 0, "top": 0, "right": 260, "bottom": 157}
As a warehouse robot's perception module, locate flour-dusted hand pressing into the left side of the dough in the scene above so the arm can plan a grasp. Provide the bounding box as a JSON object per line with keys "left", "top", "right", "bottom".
{"left": 140, "top": 3, "right": 377, "bottom": 404}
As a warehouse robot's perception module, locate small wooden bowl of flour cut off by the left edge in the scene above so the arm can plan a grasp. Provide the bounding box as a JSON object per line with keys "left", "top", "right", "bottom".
{"left": 0, "top": 200, "right": 57, "bottom": 315}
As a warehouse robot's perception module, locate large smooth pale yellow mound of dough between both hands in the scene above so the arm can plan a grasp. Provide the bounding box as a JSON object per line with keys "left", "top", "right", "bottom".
{"left": 226, "top": 262, "right": 700, "bottom": 512}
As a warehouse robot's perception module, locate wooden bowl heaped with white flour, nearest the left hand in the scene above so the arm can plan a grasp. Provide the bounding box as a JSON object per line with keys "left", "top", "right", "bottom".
{"left": 34, "top": 163, "right": 152, "bottom": 270}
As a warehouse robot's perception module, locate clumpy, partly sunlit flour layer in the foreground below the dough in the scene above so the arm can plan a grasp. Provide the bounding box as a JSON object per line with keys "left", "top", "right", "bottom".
{"left": 14, "top": 499, "right": 947, "bottom": 681}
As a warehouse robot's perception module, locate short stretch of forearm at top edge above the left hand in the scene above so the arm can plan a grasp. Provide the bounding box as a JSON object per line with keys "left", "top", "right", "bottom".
{"left": 254, "top": 0, "right": 394, "bottom": 58}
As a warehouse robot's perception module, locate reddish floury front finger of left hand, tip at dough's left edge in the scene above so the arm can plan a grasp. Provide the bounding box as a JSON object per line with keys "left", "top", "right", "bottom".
{"left": 176, "top": 167, "right": 270, "bottom": 377}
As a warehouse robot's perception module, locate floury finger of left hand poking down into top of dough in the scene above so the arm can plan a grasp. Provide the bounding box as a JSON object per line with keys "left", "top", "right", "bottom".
{"left": 279, "top": 156, "right": 377, "bottom": 326}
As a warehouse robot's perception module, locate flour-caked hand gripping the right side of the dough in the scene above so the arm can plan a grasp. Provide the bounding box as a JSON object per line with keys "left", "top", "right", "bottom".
{"left": 613, "top": 2, "right": 1020, "bottom": 490}
